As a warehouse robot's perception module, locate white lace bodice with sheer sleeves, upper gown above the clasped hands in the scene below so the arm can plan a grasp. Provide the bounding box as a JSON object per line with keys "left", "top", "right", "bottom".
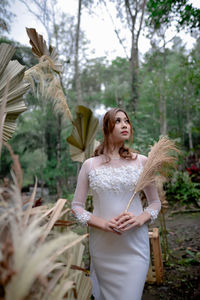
{"left": 72, "top": 154, "right": 161, "bottom": 224}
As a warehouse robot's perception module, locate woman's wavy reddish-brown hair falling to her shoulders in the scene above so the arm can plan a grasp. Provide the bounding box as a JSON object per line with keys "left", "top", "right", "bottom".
{"left": 94, "top": 108, "right": 138, "bottom": 161}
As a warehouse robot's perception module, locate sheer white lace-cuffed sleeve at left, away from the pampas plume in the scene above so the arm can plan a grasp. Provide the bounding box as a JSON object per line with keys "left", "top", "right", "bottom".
{"left": 72, "top": 159, "right": 91, "bottom": 225}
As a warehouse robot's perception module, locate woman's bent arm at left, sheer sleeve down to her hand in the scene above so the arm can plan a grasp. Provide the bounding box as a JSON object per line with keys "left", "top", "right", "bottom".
{"left": 72, "top": 159, "right": 119, "bottom": 234}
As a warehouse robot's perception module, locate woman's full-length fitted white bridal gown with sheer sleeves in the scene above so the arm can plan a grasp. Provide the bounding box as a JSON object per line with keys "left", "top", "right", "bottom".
{"left": 72, "top": 154, "right": 161, "bottom": 300}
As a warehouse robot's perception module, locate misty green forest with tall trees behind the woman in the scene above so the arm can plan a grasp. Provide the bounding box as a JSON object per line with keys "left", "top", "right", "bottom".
{"left": 0, "top": 0, "right": 200, "bottom": 204}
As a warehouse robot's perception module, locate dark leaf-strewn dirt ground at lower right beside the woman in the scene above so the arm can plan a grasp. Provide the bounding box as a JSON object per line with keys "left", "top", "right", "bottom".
{"left": 142, "top": 209, "right": 200, "bottom": 300}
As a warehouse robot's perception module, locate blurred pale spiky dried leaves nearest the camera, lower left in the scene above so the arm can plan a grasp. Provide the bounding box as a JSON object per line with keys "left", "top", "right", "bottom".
{"left": 1, "top": 182, "right": 88, "bottom": 300}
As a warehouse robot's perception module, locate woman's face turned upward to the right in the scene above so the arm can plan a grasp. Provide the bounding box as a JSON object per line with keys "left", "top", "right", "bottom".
{"left": 111, "top": 111, "right": 131, "bottom": 144}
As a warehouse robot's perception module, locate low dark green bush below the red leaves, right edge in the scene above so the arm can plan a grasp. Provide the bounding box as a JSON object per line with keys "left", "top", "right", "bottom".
{"left": 165, "top": 171, "right": 200, "bottom": 205}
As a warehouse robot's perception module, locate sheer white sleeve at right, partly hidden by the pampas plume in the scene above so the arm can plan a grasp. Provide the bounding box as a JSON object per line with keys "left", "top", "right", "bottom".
{"left": 140, "top": 155, "right": 161, "bottom": 222}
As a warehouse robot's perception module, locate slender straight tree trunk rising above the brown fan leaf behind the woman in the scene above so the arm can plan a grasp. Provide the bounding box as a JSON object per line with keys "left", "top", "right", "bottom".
{"left": 74, "top": 0, "right": 82, "bottom": 104}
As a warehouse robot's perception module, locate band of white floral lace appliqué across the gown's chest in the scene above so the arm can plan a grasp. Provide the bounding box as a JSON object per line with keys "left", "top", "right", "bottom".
{"left": 88, "top": 166, "right": 142, "bottom": 193}
